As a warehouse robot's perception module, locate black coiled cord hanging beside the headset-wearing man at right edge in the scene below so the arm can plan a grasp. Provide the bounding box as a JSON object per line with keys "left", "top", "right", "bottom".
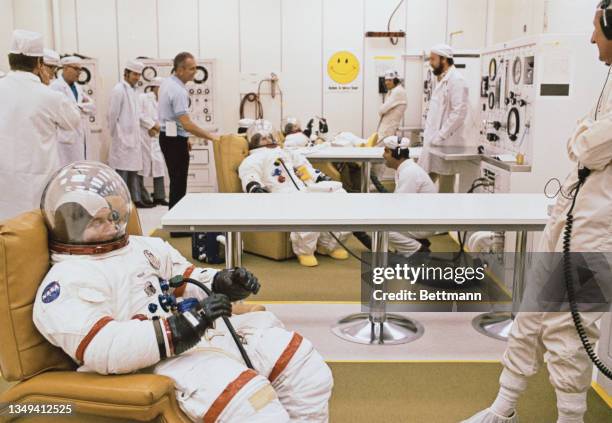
{"left": 563, "top": 167, "right": 612, "bottom": 380}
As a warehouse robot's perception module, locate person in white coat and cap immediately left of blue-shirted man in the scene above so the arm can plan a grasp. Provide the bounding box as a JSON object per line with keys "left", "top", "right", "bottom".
{"left": 138, "top": 76, "right": 168, "bottom": 206}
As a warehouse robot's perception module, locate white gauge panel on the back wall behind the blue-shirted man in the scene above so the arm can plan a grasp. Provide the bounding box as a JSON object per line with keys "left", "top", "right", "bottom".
{"left": 136, "top": 59, "right": 215, "bottom": 129}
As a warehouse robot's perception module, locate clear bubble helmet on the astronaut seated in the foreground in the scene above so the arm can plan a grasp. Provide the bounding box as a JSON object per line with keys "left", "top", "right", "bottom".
{"left": 40, "top": 161, "right": 132, "bottom": 255}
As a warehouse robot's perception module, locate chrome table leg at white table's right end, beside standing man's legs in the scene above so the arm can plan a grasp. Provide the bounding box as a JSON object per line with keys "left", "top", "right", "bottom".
{"left": 472, "top": 231, "right": 527, "bottom": 341}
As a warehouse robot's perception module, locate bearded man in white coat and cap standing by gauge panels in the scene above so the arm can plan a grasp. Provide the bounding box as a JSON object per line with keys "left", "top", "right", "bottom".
{"left": 419, "top": 44, "right": 469, "bottom": 192}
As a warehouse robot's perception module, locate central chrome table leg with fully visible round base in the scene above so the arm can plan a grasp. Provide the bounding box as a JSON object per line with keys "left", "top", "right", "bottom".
{"left": 331, "top": 232, "right": 424, "bottom": 345}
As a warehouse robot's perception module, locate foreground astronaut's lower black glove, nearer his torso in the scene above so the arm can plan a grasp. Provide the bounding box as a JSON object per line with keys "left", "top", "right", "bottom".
{"left": 167, "top": 294, "right": 232, "bottom": 355}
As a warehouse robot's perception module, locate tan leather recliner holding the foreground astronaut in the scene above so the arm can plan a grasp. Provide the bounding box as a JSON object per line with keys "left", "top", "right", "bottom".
{"left": 0, "top": 208, "right": 262, "bottom": 422}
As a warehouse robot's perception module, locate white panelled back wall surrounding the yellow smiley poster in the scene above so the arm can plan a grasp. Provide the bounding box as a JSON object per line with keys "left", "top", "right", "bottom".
{"left": 0, "top": 0, "right": 490, "bottom": 157}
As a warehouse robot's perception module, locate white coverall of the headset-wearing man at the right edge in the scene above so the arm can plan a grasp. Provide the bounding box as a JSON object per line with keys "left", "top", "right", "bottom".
{"left": 500, "top": 72, "right": 612, "bottom": 398}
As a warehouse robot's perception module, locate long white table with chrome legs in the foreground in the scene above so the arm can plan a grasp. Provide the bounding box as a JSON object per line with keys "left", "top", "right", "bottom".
{"left": 162, "top": 193, "right": 551, "bottom": 344}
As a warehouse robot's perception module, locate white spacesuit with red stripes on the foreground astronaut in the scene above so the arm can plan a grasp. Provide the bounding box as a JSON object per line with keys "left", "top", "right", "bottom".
{"left": 33, "top": 236, "right": 333, "bottom": 423}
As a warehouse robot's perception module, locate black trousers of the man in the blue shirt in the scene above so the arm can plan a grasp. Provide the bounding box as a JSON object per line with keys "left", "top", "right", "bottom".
{"left": 159, "top": 132, "right": 189, "bottom": 209}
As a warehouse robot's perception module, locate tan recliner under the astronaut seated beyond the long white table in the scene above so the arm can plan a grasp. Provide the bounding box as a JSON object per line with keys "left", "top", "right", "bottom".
{"left": 213, "top": 134, "right": 294, "bottom": 260}
